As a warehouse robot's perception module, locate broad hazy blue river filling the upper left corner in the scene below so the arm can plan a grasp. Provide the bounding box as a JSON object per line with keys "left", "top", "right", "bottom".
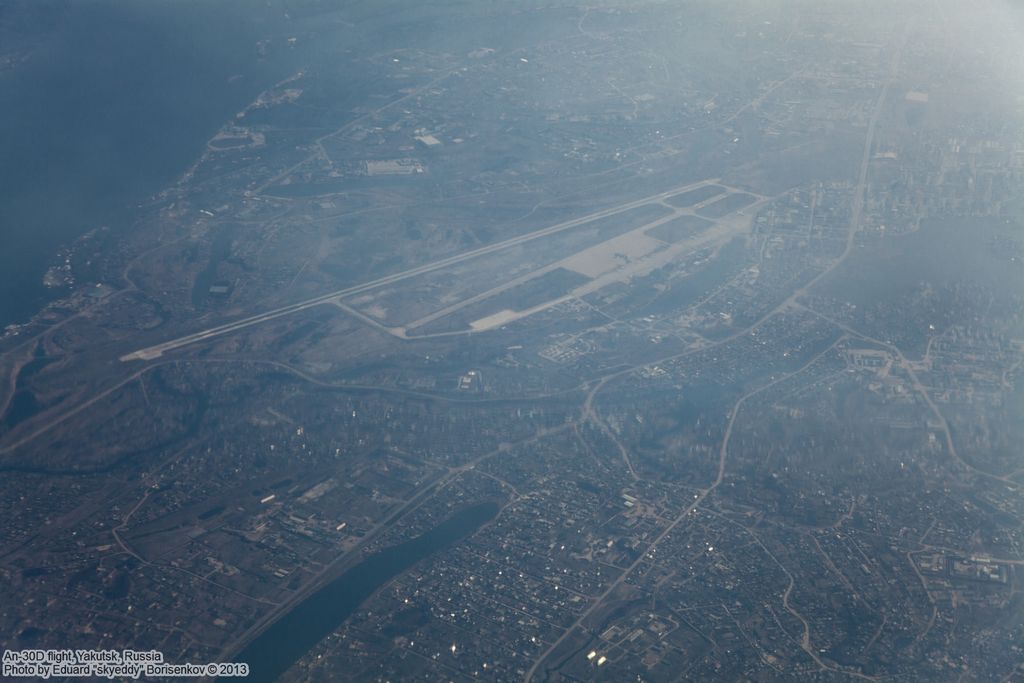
{"left": 0, "top": 0, "right": 301, "bottom": 330}
